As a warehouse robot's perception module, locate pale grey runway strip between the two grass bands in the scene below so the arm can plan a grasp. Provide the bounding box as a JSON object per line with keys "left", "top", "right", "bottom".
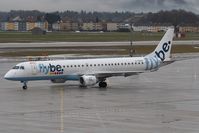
{"left": 0, "top": 40, "right": 199, "bottom": 49}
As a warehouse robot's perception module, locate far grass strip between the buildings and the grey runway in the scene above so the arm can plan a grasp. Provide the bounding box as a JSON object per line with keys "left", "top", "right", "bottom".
{"left": 0, "top": 32, "right": 196, "bottom": 43}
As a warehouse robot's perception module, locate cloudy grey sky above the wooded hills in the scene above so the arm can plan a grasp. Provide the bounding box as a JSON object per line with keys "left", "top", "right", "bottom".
{"left": 0, "top": 0, "right": 199, "bottom": 14}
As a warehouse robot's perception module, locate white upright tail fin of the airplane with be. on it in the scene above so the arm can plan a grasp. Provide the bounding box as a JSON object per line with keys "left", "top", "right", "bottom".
{"left": 145, "top": 28, "right": 174, "bottom": 62}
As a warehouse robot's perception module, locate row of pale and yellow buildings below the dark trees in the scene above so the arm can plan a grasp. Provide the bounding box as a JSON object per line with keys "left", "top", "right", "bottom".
{"left": 0, "top": 17, "right": 199, "bottom": 33}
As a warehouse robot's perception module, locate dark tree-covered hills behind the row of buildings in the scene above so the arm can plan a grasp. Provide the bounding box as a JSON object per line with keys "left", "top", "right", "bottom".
{"left": 0, "top": 10, "right": 199, "bottom": 26}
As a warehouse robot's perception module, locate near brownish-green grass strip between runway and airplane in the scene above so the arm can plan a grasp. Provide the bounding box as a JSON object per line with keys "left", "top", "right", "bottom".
{"left": 0, "top": 45, "right": 199, "bottom": 57}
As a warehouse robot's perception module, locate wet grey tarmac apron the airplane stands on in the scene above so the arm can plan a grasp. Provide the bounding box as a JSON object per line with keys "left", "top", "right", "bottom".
{"left": 0, "top": 55, "right": 199, "bottom": 133}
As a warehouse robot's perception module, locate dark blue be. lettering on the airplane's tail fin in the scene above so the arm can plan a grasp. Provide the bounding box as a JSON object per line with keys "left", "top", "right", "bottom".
{"left": 155, "top": 41, "right": 171, "bottom": 61}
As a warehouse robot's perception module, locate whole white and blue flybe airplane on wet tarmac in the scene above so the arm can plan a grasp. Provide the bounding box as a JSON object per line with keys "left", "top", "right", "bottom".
{"left": 4, "top": 28, "right": 174, "bottom": 90}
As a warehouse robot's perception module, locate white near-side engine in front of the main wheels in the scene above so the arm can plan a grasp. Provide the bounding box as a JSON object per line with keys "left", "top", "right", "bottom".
{"left": 79, "top": 75, "right": 98, "bottom": 86}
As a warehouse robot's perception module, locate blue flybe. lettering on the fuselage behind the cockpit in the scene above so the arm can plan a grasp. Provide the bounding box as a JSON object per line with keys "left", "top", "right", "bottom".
{"left": 38, "top": 64, "right": 64, "bottom": 75}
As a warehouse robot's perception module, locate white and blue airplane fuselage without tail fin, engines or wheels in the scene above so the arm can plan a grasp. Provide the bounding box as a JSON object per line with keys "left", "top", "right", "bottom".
{"left": 5, "top": 57, "right": 160, "bottom": 81}
